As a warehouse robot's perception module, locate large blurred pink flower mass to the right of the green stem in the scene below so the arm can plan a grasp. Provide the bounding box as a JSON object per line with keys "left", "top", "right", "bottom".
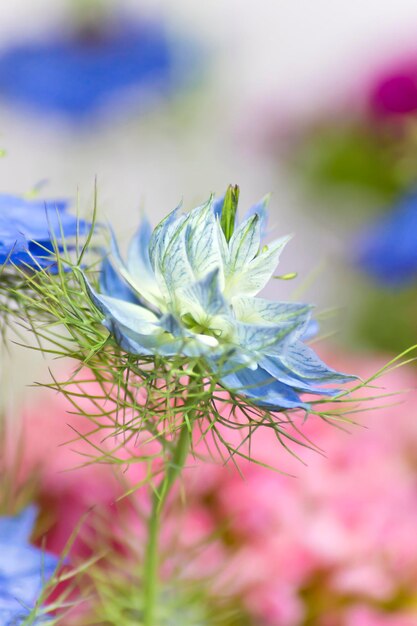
{"left": 186, "top": 358, "right": 417, "bottom": 626}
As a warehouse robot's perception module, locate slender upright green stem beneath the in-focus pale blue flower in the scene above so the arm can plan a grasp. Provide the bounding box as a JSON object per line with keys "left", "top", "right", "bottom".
{"left": 144, "top": 421, "right": 191, "bottom": 626}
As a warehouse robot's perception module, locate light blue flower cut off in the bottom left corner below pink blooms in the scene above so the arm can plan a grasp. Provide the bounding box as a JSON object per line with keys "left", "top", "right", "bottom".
{"left": 0, "top": 507, "right": 59, "bottom": 626}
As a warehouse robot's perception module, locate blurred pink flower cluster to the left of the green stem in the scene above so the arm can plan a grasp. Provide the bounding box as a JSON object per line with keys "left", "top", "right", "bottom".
{"left": 9, "top": 382, "right": 127, "bottom": 554}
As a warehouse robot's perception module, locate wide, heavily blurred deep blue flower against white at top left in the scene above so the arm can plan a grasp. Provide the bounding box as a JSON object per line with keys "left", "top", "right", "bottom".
{"left": 0, "top": 21, "right": 185, "bottom": 120}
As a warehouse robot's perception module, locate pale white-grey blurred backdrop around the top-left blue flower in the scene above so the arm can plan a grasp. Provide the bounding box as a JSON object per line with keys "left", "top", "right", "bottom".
{"left": 0, "top": 0, "right": 417, "bottom": 239}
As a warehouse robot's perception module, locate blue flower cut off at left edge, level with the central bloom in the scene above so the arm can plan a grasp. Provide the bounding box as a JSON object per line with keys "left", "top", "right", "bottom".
{"left": 0, "top": 194, "right": 88, "bottom": 269}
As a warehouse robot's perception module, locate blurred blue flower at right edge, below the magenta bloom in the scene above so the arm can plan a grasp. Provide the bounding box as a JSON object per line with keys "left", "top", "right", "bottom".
{"left": 356, "top": 191, "right": 417, "bottom": 286}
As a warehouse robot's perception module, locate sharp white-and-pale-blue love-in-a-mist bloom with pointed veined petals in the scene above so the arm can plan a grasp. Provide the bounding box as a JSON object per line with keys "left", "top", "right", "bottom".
{"left": 88, "top": 187, "right": 350, "bottom": 409}
